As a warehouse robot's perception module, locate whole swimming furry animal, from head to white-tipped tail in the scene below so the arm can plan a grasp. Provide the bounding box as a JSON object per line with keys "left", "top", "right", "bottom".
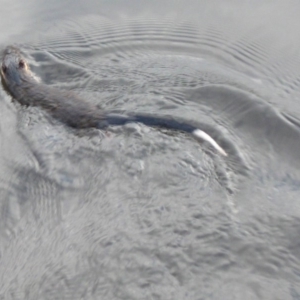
{"left": 1, "top": 47, "right": 227, "bottom": 156}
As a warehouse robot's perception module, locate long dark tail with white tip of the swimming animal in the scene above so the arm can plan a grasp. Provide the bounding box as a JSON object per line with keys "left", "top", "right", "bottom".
{"left": 98, "top": 114, "right": 227, "bottom": 156}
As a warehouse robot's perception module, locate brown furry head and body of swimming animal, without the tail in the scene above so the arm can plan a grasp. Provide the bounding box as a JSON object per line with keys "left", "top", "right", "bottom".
{"left": 1, "top": 47, "right": 104, "bottom": 128}
